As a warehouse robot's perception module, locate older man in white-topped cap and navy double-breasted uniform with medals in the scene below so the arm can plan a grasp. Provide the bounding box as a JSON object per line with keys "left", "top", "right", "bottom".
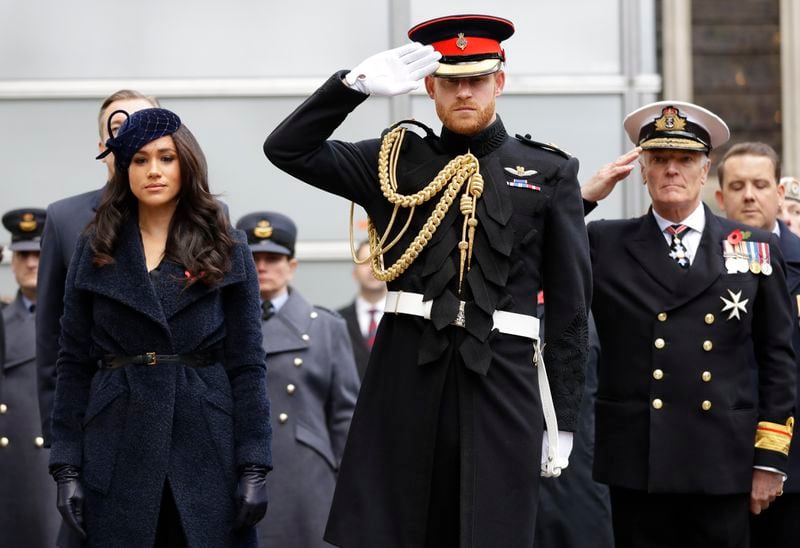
{"left": 588, "top": 101, "right": 795, "bottom": 548}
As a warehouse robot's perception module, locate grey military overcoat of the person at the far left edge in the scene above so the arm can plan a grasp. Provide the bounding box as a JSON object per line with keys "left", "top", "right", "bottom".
{"left": 0, "top": 293, "right": 61, "bottom": 547}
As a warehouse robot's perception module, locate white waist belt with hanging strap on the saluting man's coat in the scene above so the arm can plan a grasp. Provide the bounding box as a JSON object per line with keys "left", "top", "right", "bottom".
{"left": 384, "top": 291, "right": 566, "bottom": 477}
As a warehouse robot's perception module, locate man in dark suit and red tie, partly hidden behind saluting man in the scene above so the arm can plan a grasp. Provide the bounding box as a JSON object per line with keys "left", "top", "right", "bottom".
{"left": 337, "top": 242, "right": 386, "bottom": 380}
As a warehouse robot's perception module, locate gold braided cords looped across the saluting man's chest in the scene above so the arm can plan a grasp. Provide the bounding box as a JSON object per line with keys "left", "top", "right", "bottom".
{"left": 350, "top": 126, "right": 483, "bottom": 290}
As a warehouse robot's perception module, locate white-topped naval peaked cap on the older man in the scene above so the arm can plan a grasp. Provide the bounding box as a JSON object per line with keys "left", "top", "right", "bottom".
{"left": 623, "top": 101, "right": 731, "bottom": 153}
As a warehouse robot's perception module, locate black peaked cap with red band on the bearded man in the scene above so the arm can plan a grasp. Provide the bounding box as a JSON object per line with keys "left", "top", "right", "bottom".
{"left": 408, "top": 15, "right": 514, "bottom": 78}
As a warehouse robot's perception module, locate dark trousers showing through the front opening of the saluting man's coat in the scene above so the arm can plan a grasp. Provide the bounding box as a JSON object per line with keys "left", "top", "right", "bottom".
{"left": 425, "top": 359, "right": 463, "bottom": 548}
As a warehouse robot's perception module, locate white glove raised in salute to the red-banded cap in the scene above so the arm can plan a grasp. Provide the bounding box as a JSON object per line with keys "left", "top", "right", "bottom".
{"left": 344, "top": 42, "right": 442, "bottom": 97}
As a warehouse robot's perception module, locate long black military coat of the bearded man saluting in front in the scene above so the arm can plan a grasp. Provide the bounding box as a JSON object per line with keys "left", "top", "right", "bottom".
{"left": 264, "top": 73, "right": 591, "bottom": 548}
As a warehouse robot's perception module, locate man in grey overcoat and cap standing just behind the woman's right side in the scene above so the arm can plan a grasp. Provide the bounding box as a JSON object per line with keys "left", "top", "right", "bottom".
{"left": 236, "top": 211, "right": 359, "bottom": 548}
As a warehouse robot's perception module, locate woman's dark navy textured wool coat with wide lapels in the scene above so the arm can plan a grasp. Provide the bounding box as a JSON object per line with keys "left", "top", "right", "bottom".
{"left": 50, "top": 218, "right": 271, "bottom": 547}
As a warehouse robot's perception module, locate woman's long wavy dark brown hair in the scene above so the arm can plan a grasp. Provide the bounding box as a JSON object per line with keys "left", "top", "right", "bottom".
{"left": 87, "top": 125, "right": 235, "bottom": 286}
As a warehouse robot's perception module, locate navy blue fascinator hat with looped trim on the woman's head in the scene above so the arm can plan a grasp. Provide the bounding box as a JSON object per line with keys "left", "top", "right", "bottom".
{"left": 96, "top": 108, "right": 181, "bottom": 170}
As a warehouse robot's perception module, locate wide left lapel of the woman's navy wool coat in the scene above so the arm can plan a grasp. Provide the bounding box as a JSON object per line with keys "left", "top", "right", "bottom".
{"left": 75, "top": 219, "right": 169, "bottom": 331}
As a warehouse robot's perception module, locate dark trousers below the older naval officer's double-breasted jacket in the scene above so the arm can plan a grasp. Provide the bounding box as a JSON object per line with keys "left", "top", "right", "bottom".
{"left": 610, "top": 486, "right": 750, "bottom": 548}
